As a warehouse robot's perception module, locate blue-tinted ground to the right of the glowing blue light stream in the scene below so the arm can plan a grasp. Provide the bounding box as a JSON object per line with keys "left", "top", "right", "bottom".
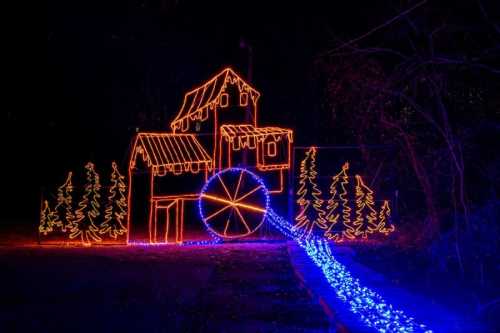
{"left": 351, "top": 244, "right": 500, "bottom": 333}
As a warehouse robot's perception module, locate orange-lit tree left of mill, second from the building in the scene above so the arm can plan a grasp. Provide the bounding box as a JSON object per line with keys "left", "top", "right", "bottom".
{"left": 69, "top": 162, "right": 101, "bottom": 245}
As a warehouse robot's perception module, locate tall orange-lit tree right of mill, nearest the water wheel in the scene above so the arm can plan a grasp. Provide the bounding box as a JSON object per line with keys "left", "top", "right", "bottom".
{"left": 294, "top": 147, "right": 327, "bottom": 237}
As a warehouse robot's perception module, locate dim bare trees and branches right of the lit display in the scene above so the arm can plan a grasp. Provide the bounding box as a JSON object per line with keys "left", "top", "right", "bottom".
{"left": 318, "top": 2, "right": 500, "bottom": 276}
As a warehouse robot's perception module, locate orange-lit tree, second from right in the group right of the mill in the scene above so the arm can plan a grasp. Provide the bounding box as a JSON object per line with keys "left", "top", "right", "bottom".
{"left": 353, "top": 175, "right": 378, "bottom": 238}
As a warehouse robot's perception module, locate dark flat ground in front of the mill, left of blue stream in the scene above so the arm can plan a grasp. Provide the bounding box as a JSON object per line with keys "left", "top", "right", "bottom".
{"left": 0, "top": 242, "right": 330, "bottom": 332}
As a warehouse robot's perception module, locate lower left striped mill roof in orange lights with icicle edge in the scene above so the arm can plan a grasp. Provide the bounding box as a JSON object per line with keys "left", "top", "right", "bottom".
{"left": 131, "top": 133, "right": 212, "bottom": 176}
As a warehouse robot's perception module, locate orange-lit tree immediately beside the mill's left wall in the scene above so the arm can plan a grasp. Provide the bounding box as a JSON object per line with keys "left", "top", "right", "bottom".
{"left": 99, "top": 162, "right": 127, "bottom": 239}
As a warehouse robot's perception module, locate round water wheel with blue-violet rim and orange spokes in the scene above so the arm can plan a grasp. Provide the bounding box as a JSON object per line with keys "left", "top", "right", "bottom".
{"left": 198, "top": 168, "right": 269, "bottom": 238}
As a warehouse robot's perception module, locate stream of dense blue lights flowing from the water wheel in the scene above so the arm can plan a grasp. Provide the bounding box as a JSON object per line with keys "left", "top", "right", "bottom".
{"left": 268, "top": 209, "right": 432, "bottom": 333}
